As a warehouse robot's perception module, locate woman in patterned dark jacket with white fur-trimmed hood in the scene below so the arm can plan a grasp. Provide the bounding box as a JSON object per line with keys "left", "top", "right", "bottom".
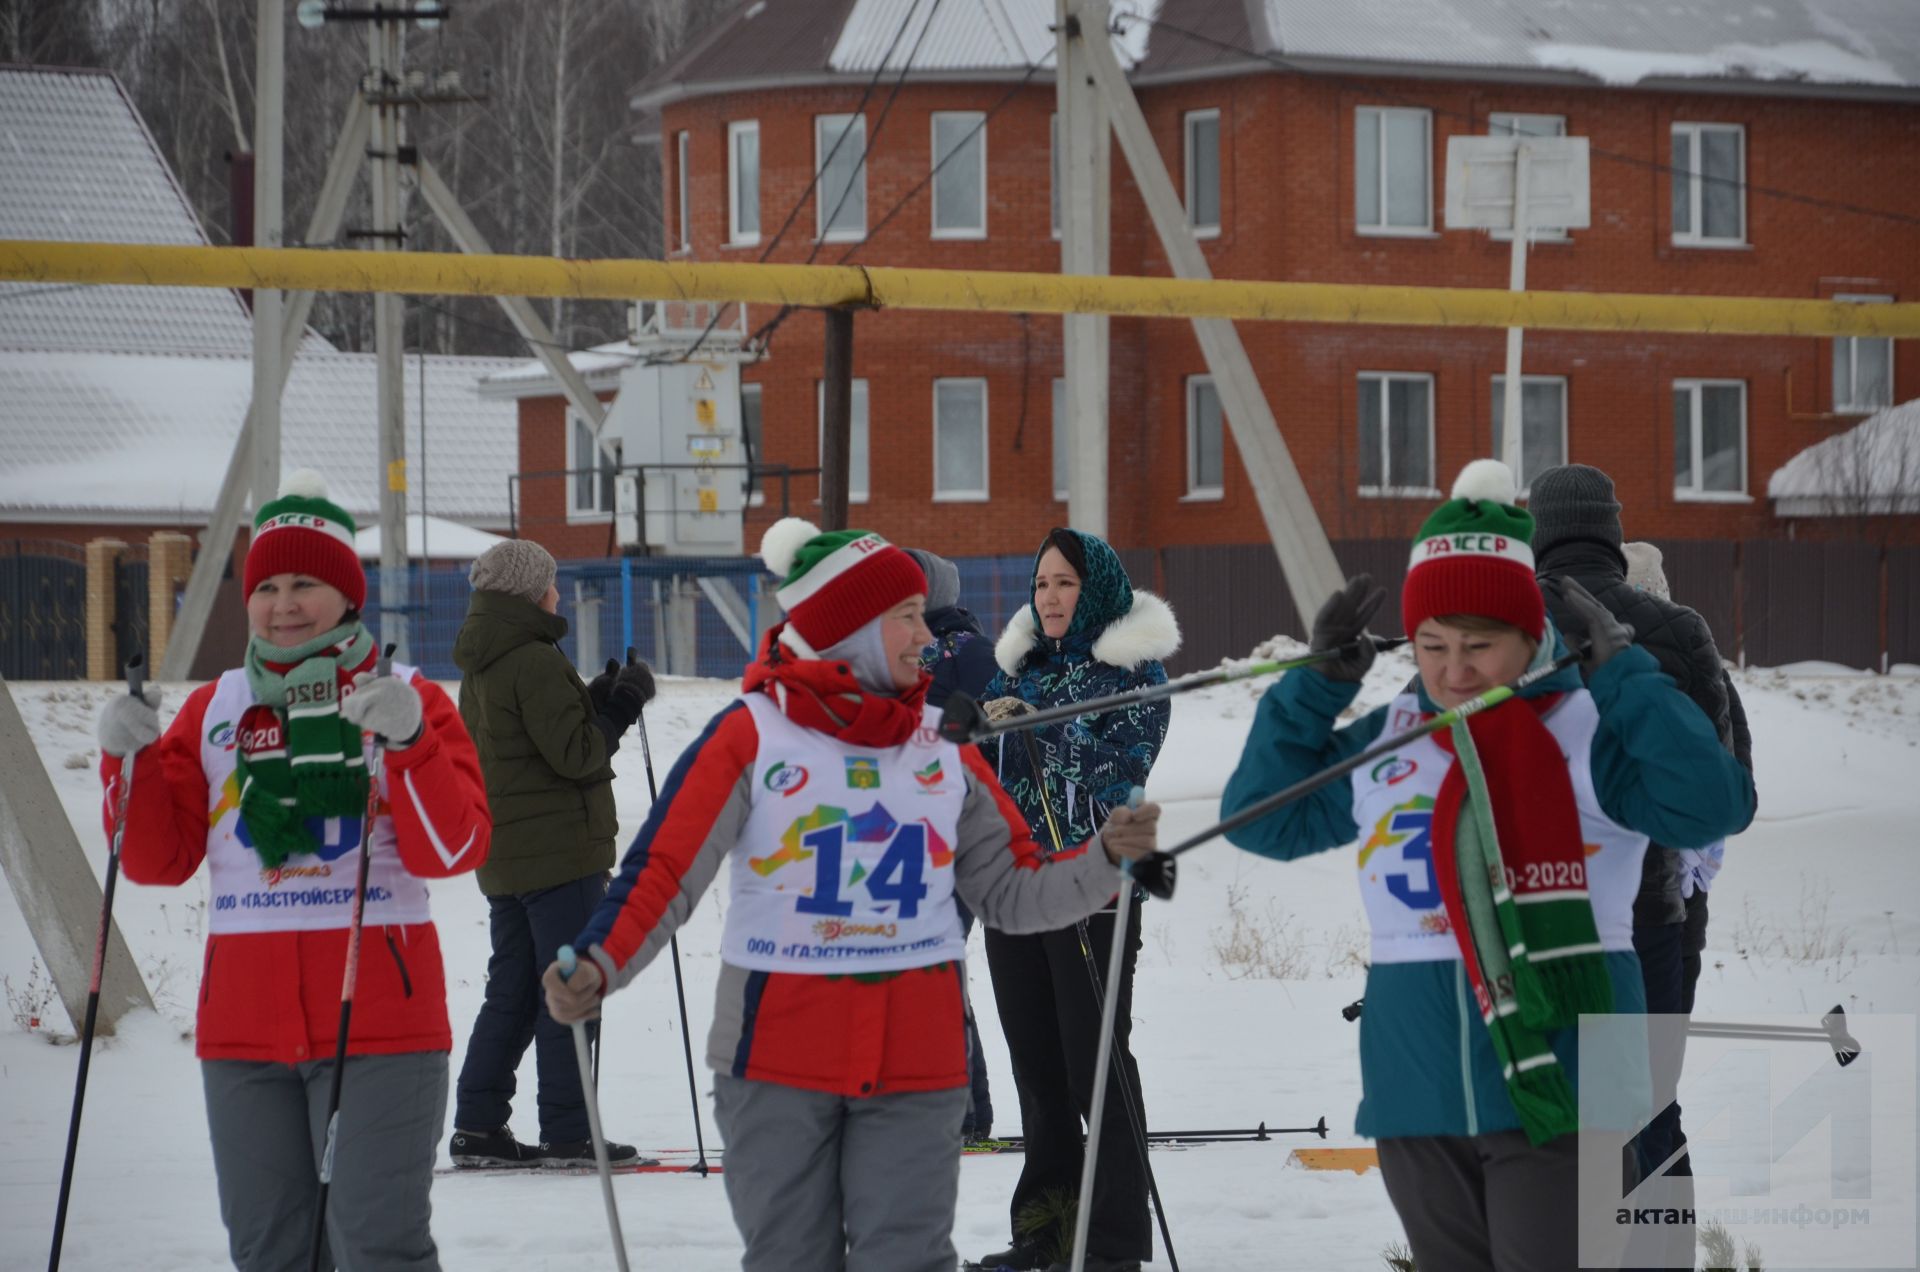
{"left": 981, "top": 530, "right": 1181, "bottom": 1272}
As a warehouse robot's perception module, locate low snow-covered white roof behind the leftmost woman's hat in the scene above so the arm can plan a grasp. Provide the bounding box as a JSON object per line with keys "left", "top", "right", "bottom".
{"left": 0, "top": 350, "right": 518, "bottom": 526}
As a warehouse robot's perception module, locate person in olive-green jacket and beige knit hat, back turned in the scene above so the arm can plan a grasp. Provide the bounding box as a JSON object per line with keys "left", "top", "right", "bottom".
{"left": 449, "top": 540, "right": 653, "bottom": 1168}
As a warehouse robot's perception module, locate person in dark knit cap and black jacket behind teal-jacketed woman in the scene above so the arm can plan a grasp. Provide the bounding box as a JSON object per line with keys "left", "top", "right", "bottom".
{"left": 1530, "top": 463, "right": 1753, "bottom": 1249}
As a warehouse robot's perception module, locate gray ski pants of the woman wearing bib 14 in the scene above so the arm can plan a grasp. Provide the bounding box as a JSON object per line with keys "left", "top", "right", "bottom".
{"left": 714, "top": 1074, "right": 968, "bottom": 1272}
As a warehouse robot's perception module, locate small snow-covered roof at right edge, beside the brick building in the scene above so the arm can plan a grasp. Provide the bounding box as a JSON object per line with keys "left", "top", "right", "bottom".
{"left": 1766, "top": 398, "right": 1920, "bottom": 517}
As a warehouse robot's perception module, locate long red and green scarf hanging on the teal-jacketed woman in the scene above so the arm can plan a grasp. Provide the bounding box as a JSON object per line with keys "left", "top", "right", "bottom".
{"left": 1432, "top": 676, "right": 1613, "bottom": 1143}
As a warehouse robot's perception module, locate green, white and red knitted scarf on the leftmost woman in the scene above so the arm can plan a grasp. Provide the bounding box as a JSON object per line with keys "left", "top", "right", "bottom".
{"left": 234, "top": 621, "right": 374, "bottom": 868}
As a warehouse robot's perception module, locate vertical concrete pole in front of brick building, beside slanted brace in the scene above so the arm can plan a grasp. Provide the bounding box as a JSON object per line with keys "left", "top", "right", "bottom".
{"left": 1054, "top": 0, "right": 1114, "bottom": 538}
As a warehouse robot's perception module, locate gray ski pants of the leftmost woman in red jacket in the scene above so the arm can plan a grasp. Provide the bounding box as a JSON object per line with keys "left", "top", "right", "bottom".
{"left": 200, "top": 1051, "right": 449, "bottom": 1272}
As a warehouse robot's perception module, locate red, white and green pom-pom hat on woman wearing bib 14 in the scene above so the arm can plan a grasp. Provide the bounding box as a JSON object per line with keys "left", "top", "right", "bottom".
{"left": 760, "top": 517, "right": 927, "bottom": 651}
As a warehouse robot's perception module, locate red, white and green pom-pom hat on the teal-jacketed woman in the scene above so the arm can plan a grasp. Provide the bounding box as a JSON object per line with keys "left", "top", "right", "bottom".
{"left": 1400, "top": 459, "right": 1548, "bottom": 640}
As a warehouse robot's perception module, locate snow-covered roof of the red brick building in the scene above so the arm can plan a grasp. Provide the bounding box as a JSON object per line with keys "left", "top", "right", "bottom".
{"left": 632, "top": 0, "right": 1920, "bottom": 111}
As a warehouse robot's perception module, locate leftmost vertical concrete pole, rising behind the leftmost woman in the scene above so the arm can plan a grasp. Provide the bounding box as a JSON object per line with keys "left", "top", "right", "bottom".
{"left": 251, "top": 0, "right": 284, "bottom": 518}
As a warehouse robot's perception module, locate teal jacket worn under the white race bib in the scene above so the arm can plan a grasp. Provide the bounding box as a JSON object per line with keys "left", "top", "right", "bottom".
{"left": 1221, "top": 636, "right": 1753, "bottom": 1139}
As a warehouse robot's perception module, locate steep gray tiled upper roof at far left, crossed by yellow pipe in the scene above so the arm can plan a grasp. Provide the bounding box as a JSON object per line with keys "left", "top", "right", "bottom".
{"left": 0, "top": 67, "right": 266, "bottom": 354}
